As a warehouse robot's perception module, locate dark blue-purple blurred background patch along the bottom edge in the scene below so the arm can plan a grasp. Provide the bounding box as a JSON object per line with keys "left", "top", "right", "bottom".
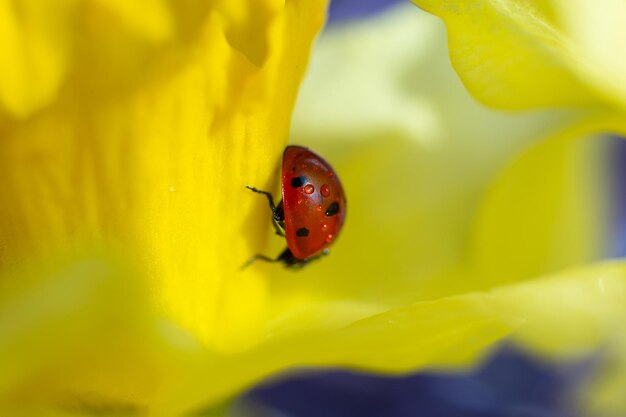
{"left": 243, "top": 348, "right": 592, "bottom": 417}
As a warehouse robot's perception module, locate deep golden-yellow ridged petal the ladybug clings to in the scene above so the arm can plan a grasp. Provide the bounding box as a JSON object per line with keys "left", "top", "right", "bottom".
{"left": 0, "top": 0, "right": 324, "bottom": 351}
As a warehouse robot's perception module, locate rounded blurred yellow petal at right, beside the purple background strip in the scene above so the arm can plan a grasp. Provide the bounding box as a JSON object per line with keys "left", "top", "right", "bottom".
{"left": 471, "top": 117, "right": 620, "bottom": 285}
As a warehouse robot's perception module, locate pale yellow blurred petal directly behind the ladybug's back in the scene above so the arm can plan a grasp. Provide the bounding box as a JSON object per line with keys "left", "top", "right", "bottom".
{"left": 272, "top": 6, "right": 603, "bottom": 318}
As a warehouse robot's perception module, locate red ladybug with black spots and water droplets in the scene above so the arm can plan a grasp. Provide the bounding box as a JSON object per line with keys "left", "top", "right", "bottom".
{"left": 244, "top": 145, "right": 346, "bottom": 269}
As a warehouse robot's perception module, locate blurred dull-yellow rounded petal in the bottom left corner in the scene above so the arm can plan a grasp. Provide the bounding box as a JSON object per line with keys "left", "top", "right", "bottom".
{"left": 0, "top": 253, "right": 173, "bottom": 415}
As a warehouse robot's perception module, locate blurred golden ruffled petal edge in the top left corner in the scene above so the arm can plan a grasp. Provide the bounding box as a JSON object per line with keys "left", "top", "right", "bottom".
{"left": 0, "top": 0, "right": 174, "bottom": 119}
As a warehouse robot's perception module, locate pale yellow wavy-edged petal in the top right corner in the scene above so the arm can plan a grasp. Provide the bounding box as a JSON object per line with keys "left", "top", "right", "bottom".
{"left": 414, "top": 0, "right": 626, "bottom": 109}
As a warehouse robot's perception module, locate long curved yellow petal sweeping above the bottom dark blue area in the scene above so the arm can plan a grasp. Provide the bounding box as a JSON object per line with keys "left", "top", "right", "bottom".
{"left": 157, "top": 263, "right": 626, "bottom": 415}
